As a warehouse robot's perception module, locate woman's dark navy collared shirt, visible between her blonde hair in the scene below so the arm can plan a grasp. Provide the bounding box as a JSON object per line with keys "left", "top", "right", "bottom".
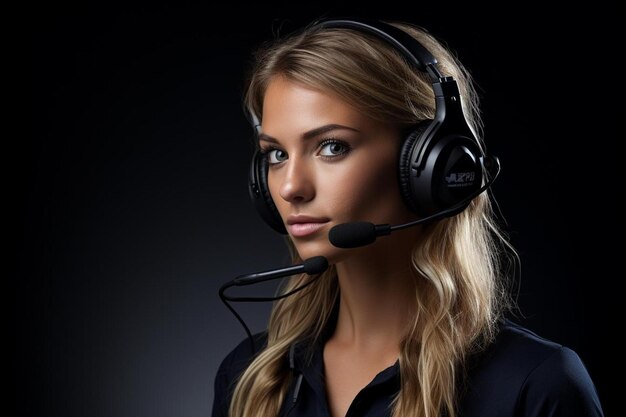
{"left": 212, "top": 320, "right": 604, "bottom": 417}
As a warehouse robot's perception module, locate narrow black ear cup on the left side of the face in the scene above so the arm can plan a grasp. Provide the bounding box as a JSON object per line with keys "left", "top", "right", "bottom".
{"left": 248, "top": 149, "right": 287, "bottom": 235}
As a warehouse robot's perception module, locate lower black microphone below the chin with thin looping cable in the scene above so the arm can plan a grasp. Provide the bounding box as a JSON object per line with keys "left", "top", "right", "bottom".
{"left": 219, "top": 256, "right": 328, "bottom": 354}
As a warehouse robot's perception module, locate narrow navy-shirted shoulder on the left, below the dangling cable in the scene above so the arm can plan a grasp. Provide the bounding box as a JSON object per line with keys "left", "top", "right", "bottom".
{"left": 211, "top": 332, "right": 267, "bottom": 417}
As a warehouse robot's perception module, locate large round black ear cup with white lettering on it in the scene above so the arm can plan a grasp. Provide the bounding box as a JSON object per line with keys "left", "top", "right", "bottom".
{"left": 398, "top": 121, "right": 483, "bottom": 217}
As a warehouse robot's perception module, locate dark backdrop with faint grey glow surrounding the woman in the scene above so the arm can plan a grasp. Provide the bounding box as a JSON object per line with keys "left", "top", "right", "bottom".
{"left": 20, "top": 2, "right": 624, "bottom": 417}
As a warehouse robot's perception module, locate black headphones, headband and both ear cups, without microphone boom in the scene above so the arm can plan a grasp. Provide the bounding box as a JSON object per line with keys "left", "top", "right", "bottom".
{"left": 248, "top": 19, "right": 493, "bottom": 234}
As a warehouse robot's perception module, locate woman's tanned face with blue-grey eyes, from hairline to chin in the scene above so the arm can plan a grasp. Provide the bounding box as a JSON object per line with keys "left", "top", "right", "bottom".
{"left": 259, "top": 77, "right": 416, "bottom": 263}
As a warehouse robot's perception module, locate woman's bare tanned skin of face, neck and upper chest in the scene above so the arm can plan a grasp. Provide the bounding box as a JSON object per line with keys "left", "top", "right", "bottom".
{"left": 259, "top": 77, "right": 420, "bottom": 416}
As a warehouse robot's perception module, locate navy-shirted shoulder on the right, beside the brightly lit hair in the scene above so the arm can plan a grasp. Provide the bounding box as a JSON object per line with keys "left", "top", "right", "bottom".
{"left": 456, "top": 320, "right": 602, "bottom": 416}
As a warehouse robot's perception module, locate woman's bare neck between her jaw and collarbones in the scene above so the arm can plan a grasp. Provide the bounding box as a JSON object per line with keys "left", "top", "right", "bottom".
{"left": 333, "top": 224, "right": 416, "bottom": 352}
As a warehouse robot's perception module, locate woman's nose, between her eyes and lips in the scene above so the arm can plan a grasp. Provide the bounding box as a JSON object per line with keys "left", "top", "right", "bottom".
{"left": 277, "top": 157, "right": 315, "bottom": 203}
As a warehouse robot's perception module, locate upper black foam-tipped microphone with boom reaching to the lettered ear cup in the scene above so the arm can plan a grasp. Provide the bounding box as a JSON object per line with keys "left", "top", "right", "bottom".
{"left": 328, "top": 156, "right": 500, "bottom": 249}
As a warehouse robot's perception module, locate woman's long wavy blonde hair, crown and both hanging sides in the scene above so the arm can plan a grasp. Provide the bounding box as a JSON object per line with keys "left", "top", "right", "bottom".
{"left": 230, "top": 22, "right": 514, "bottom": 417}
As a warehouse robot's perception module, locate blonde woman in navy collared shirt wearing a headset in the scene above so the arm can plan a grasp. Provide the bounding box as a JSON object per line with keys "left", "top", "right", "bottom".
{"left": 213, "top": 17, "right": 602, "bottom": 417}
